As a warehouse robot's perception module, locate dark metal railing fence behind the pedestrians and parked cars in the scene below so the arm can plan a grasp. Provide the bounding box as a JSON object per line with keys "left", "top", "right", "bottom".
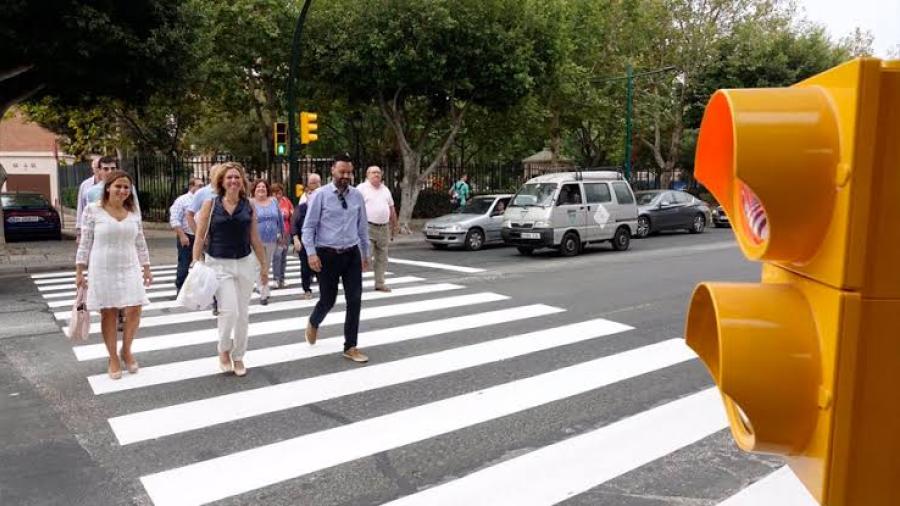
{"left": 59, "top": 155, "right": 704, "bottom": 221}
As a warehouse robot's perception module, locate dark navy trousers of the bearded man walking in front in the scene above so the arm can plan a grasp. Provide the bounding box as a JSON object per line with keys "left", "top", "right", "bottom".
{"left": 309, "top": 248, "right": 362, "bottom": 351}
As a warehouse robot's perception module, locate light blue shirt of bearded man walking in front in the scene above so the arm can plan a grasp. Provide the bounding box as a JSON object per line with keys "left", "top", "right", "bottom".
{"left": 300, "top": 183, "right": 369, "bottom": 258}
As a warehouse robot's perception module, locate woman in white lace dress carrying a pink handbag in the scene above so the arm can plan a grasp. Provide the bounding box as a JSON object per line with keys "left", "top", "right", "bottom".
{"left": 75, "top": 171, "right": 153, "bottom": 379}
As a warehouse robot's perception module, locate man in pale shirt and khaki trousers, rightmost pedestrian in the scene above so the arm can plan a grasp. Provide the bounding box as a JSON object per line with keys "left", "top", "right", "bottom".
{"left": 356, "top": 165, "right": 397, "bottom": 292}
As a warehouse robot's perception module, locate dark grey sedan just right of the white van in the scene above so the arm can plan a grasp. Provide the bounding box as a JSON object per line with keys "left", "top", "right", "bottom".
{"left": 635, "top": 190, "right": 709, "bottom": 238}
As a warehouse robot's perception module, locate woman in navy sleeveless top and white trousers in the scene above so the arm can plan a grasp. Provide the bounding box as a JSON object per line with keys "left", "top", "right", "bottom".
{"left": 193, "top": 162, "right": 269, "bottom": 376}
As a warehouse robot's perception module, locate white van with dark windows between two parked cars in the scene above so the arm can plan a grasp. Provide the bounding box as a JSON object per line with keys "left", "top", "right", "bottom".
{"left": 501, "top": 171, "right": 638, "bottom": 256}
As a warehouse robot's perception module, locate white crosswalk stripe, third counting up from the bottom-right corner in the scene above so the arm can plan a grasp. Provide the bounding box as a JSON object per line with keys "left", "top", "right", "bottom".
{"left": 141, "top": 339, "right": 696, "bottom": 506}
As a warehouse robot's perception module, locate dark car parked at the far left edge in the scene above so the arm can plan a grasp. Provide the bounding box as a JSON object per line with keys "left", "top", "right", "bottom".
{"left": 0, "top": 192, "right": 62, "bottom": 240}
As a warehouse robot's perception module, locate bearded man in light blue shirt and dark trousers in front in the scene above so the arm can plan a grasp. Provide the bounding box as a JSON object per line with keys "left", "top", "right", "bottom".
{"left": 301, "top": 155, "right": 369, "bottom": 362}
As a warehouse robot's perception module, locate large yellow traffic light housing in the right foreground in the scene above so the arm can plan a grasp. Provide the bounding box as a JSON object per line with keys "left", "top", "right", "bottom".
{"left": 685, "top": 58, "right": 900, "bottom": 506}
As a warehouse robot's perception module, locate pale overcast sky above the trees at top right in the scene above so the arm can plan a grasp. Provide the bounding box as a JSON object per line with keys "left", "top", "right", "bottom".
{"left": 797, "top": 0, "right": 900, "bottom": 58}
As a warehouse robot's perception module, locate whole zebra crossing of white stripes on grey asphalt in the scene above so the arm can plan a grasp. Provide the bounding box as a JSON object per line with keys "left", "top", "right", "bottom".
{"left": 32, "top": 258, "right": 815, "bottom": 506}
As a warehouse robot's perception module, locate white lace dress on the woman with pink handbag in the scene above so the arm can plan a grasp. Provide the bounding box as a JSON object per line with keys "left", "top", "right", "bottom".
{"left": 75, "top": 203, "right": 150, "bottom": 311}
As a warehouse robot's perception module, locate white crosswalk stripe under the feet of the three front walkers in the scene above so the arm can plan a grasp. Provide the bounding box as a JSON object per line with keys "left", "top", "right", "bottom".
{"left": 88, "top": 304, "right": 565, "bottom": 395}
